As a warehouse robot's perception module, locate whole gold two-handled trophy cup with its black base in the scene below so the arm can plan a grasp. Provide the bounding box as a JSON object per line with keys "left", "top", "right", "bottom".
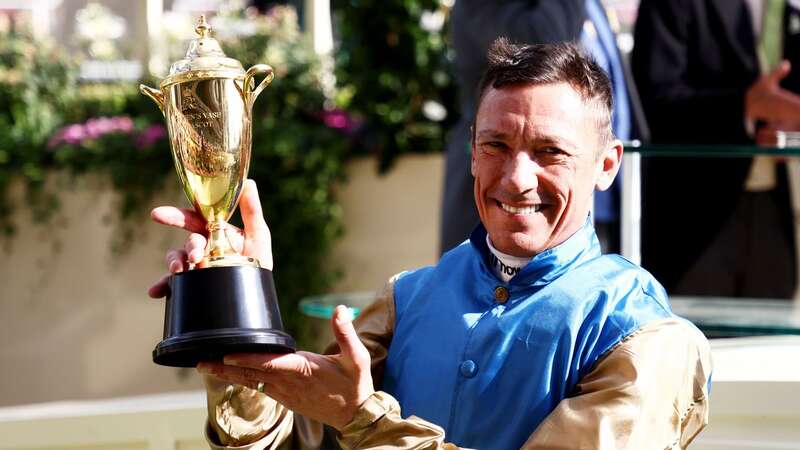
{"left": 139, "top": 16, "right": 295, "bottom": 367}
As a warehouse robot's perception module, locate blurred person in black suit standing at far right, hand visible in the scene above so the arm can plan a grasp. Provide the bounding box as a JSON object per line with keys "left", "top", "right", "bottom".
{"left": 632, "top": 0, "right": 800, "bottom": 298}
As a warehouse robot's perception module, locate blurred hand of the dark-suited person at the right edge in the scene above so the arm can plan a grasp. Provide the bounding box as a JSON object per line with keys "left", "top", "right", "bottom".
{"left": 744, "top": 60, "right": 800, "bottom": 124}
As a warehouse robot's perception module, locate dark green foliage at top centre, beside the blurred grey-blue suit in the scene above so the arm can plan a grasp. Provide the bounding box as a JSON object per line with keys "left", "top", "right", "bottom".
{"left": 332, "top": 0, "right": 457, "bottom": 170}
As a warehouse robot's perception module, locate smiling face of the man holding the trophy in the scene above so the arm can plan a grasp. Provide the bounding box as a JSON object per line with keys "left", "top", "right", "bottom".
{"left": 472, "top": 83, "right": 622, "bottom": 256}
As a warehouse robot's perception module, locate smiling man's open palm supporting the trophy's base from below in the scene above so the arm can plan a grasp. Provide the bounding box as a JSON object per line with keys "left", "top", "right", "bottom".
{"left": 197, "top": 306, "right": 374, "bottom": 430}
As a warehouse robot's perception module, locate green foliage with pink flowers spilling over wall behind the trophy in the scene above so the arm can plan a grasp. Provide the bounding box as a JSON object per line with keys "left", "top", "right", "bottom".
{"left": 0, "top": 8, "right": 348, "bottom": 340}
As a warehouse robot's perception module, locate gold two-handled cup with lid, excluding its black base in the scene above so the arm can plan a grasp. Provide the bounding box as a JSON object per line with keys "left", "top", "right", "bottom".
{"left": 141, "top": 16, "right": 273, "bottom": 267}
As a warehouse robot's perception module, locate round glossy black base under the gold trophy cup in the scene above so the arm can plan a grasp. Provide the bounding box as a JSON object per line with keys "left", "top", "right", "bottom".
{"left": 153, "top": 266, "right": 295, "bottom": 367}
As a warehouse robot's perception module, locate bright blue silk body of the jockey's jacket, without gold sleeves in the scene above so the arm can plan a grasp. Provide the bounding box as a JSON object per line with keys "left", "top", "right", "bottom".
{"left": 382, "top": 221, "right": 673, "bottom": 450}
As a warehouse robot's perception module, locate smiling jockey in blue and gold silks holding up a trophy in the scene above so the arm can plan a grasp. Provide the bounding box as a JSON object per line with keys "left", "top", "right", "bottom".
{"left": 151, "top": 39, "right": 711, "bottom": 449}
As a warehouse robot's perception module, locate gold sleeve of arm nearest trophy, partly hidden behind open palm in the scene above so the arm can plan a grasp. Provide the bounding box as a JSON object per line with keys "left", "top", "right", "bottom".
{"left": 203, "top": 277, "right": 396, "bottom": 450}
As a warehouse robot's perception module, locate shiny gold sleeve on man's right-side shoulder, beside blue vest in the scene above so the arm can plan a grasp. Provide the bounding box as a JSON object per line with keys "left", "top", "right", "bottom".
{"left": 523, "top": 319, "right": 711, "bottom": 450}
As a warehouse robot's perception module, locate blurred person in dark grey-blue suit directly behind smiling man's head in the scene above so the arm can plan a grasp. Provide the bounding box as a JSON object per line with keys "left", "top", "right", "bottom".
{"left": 440, "top": 0, "right": 647, "bottom": 253}
